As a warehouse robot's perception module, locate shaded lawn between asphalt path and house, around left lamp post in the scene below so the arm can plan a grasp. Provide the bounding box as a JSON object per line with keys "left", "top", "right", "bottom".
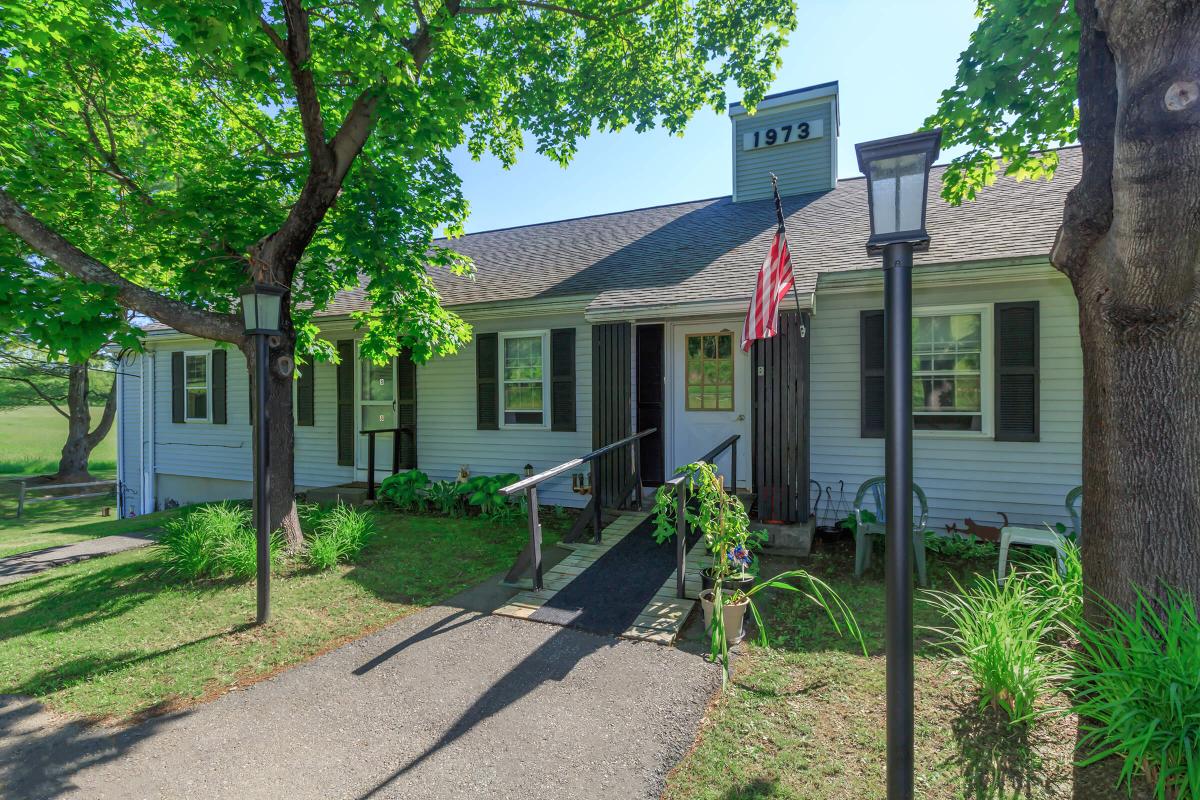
{"left": 0, "top": 512, "right": 557, "bottom": 721}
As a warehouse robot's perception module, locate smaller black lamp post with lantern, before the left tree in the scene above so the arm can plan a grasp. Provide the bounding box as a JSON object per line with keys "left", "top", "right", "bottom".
{"left": 239, "top": 283, "right": 284, "bottom": 625}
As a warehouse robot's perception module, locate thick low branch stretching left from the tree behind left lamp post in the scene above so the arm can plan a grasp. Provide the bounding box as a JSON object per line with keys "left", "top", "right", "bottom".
{"left": 0, "top": 190, "right": 245, "bottom": 345}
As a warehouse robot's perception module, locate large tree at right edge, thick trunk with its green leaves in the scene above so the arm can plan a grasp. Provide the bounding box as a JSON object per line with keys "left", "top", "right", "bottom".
{"left": 929, "top": 0, "right": 1200, "bottom": 603}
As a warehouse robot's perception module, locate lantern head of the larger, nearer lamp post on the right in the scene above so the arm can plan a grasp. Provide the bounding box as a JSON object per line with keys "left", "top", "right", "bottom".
{"left": 854, "top": 128, "right": 942, "bottom": 253}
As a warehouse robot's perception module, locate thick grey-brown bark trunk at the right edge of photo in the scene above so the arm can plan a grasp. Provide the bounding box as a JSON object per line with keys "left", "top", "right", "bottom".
{"left": 1052, "top": 0, "right": 1200, "bottom": 613}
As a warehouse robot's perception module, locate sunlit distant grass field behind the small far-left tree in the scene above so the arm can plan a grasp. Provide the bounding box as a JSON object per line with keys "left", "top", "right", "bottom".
{"left": 0, "top": 405, "right": 116, "bottom": 475}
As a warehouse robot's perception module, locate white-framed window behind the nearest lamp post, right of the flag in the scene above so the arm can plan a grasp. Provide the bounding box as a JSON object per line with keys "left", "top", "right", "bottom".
{"left": 912, "top": 309, "right": 988, "bottom": 433}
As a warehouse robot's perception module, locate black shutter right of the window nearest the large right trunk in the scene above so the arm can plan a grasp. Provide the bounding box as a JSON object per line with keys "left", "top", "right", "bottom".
{"left": 996, "top": 300, "right": 1040, "bottom": 441}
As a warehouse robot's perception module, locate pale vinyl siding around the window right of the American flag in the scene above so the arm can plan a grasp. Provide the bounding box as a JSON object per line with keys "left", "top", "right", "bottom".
{"left": 810, "top": 265, "right": 1084, "bottom": 530}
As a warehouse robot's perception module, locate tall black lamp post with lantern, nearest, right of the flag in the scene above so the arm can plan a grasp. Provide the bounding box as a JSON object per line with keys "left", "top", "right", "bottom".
{"left": 854, "top": 131, "right": 942, "bottom": 800}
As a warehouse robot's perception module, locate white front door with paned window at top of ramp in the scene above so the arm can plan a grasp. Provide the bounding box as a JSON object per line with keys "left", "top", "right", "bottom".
{"left": 668, "top": 320, "right": 751, "bottom": 487}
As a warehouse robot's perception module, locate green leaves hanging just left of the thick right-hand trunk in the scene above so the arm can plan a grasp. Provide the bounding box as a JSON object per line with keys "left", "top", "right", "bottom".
{"left": 925, "top": 0, "right": 1079, "bottom": 205}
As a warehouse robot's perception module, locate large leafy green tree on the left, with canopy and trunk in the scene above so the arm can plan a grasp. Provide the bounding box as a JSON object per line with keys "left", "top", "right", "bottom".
{"left": 0, "top": 0, "right": 794, "bottom": 537}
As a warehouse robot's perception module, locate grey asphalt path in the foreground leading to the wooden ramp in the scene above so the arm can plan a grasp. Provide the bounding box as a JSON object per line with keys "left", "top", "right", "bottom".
{"left": 0, "top": 585, "right": 720, "bottom": 800}
